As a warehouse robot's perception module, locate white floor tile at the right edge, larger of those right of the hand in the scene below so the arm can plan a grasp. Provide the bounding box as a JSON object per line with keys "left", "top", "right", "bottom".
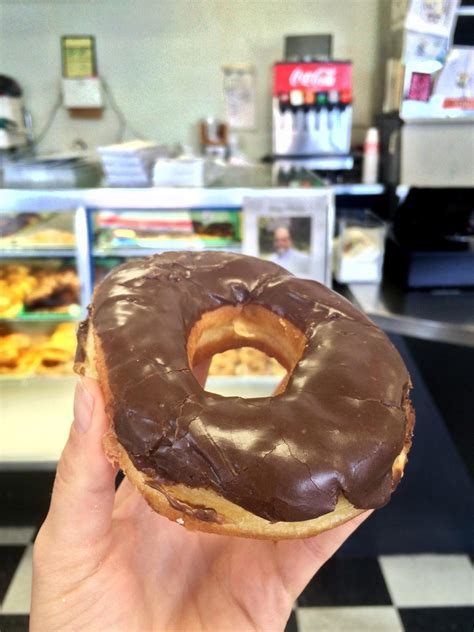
{"left": 379, "top": 555, "right": 474, "bottom": 607}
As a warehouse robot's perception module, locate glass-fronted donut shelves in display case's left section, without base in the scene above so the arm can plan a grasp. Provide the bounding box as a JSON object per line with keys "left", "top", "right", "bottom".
{"left": 0, "top": 211, "right": 82, "bottom": 380}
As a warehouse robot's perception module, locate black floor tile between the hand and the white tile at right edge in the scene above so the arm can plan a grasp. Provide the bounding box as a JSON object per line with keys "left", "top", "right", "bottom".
{"left": 298, "top": 557, "right": 392, "bottom": 606}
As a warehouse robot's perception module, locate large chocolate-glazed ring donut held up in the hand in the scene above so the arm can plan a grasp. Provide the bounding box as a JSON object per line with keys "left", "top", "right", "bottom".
{"left": 76, "top": 252, "right": 414, "bottom": 538}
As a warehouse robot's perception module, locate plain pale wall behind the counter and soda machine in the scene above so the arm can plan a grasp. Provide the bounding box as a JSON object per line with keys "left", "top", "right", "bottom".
{"left": 0, "top": 0, "right": 387, "bottom": 156}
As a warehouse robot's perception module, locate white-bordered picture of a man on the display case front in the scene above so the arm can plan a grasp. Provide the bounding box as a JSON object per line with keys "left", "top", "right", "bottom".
{"left": 243, "top": 189, "right": 334, "bottom": 286}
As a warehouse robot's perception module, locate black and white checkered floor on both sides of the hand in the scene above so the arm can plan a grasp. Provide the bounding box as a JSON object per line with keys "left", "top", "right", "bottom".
{"left": 0, "top": 527, "right": 474, "bottom": 632}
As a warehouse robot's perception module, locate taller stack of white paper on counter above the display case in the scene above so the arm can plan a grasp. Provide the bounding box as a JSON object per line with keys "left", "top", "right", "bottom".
{"left": 97, "top": 140, "right": 167, "bottom": 187}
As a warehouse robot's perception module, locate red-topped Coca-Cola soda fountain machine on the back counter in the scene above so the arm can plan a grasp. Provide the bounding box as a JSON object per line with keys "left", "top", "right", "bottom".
{"left": 273, "top": 61, "right": 353, "bottom": 170}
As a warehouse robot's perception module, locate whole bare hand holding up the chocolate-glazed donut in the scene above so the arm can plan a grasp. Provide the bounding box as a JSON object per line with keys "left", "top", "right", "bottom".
{"left": 30, "top": 375, "right": 369, "bottom": 632}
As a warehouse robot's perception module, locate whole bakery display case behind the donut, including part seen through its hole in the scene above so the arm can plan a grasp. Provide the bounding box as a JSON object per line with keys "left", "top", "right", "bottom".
{"left": 0, "top": 180, "right": 334, "bottom": 468}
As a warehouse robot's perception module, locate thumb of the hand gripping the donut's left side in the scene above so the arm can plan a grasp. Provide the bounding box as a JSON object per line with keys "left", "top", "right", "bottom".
{"left": 45, "top": 378, "right": 116, "bottom": 546}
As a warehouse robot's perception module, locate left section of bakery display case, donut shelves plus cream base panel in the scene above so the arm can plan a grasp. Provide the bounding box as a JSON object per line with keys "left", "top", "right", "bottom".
{"left": 0, "top": 212, "right": 82, "bottom": 468}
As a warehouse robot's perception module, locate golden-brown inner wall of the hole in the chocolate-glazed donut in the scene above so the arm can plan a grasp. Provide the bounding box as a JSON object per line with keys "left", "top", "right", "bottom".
{"left": 187, "top": 304, "right": 307, "bottom": 394}
